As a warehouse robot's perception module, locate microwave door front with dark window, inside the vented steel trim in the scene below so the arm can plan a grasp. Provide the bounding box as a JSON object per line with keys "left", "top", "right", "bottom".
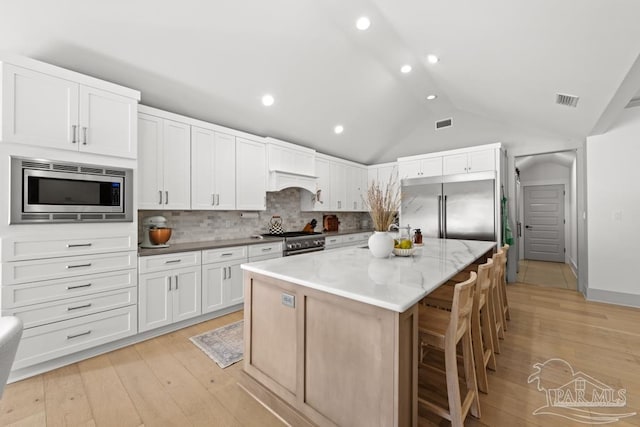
{"left": 22, "top": 169, "right": 124, "bottom": 213}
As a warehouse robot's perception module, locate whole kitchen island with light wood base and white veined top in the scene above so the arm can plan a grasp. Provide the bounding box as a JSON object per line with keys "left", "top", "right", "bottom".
{"left": 242, "top": 239, "right": 495, "bottom": 426}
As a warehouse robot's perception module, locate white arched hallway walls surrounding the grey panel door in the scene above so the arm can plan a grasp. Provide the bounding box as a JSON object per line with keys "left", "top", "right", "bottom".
{"left": 517, "top": 162, "right": 575, "bottom": 262}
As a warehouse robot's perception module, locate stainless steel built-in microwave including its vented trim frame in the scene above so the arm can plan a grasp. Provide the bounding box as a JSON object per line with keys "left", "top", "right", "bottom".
{"left": 10, "top": 157, "right": 133, "bottom": 224}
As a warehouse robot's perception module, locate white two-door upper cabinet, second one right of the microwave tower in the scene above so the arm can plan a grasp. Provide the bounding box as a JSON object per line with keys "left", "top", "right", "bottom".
{"left": 191, "top": 126, "right": 236, "bottom": 210}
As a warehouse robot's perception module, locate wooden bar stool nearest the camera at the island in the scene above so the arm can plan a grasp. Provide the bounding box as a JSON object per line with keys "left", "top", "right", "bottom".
{"left": 418, "top": 272, "right": 480, "bottom": 426}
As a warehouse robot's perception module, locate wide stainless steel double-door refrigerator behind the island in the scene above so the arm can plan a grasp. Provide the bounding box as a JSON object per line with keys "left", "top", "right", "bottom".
{"left": 400, "top": 172, "right": 497, "bottom": 241}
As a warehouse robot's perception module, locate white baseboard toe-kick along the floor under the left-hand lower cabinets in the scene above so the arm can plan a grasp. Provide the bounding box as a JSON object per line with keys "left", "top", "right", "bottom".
{"left": 7, "top": 304, "right": 244, "bottom": 383}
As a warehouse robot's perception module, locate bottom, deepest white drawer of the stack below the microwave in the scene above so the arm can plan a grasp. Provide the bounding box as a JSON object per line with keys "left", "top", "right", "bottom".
{"left": 13, "top": 305, "right": 138, "bottom": 370}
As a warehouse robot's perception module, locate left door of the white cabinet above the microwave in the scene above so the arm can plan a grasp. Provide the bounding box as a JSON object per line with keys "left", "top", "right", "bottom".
{"left": 2, "top": 64, "right": 78, "bottom": 150}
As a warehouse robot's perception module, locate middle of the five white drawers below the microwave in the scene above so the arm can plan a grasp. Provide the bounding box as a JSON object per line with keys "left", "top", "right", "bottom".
{"left": 2, "top": 269, "right": 138, "bottom": 310}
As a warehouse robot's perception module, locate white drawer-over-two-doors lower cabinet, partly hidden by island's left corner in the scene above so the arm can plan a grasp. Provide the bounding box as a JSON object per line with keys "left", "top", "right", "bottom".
{"left": 202, "top": 246, "right": 247, "bottom": 313}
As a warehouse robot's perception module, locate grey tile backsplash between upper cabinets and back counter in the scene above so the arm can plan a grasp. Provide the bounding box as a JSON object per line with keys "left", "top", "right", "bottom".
{"left": 138, "top": 188, "right": 370, "bottom": 243}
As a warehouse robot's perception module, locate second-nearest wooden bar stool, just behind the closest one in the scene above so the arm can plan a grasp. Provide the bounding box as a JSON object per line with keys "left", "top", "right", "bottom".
{"left": 423, "top": 259, "right": 496, "bottom": 393}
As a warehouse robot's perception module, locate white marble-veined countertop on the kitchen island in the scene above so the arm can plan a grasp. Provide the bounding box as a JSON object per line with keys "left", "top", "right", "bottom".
{"left": 242, "top": 238, "right": 495, "bottom": 313}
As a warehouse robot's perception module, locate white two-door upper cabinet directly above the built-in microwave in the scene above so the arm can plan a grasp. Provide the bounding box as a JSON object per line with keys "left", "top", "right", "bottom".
{"left": 2, "top": 61, "right": 139, "bottom": 158}
